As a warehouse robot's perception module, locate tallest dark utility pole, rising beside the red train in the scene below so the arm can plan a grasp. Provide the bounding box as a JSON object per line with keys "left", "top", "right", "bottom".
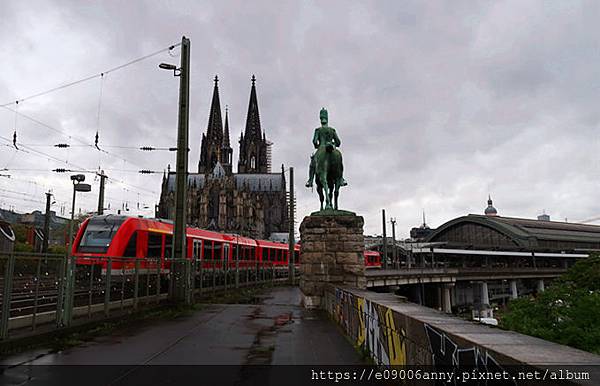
{"left": 172, "top": 36, "right": 190, "bottom": 302}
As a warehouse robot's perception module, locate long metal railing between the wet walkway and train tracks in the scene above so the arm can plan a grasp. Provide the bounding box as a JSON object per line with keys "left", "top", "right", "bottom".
{"left": 0, "top": 253, "right": 288, "bottom": 340}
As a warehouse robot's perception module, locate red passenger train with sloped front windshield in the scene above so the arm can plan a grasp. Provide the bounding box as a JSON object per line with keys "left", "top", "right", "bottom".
{"left": 72, "top": 215, "right": 381, "bottom": 272}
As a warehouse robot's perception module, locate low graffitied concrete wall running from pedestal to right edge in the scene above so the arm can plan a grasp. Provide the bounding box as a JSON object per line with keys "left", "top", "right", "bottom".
{"left": 323, "top": 286, "right": 600, "bottom": 371}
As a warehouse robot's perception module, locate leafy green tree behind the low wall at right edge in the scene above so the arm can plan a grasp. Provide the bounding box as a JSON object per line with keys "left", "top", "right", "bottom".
{"left": 500, "top": 256, "right": 600, "bottom": 354}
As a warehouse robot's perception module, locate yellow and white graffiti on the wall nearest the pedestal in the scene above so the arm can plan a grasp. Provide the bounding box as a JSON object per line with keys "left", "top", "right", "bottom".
{"left": 333, "top": 289, "right": 406, "bottom": 366}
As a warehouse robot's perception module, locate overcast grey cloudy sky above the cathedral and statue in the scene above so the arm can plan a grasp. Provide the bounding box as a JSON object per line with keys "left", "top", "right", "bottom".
{"left": 0, "top": 0, "right": 600, "bottom": 237}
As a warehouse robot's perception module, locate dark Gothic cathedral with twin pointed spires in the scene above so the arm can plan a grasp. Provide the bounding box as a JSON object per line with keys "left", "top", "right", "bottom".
{"left": 158, "top": 75, "right": 288, "bottom": 239}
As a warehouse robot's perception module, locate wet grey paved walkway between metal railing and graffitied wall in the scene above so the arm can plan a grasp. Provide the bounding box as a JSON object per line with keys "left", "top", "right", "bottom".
{"left": 0, "top": 287, "right": 363, "bottom": 386}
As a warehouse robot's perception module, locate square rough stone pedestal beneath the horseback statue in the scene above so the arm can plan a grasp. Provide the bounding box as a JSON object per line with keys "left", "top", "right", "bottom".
{"left": 300, "top": 212, "right": 366, "bottom": 308}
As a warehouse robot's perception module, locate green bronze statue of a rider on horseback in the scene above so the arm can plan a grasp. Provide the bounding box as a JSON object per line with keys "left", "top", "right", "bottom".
{"left": 306, "top": 108, "right": 348, "bottom": 210}
